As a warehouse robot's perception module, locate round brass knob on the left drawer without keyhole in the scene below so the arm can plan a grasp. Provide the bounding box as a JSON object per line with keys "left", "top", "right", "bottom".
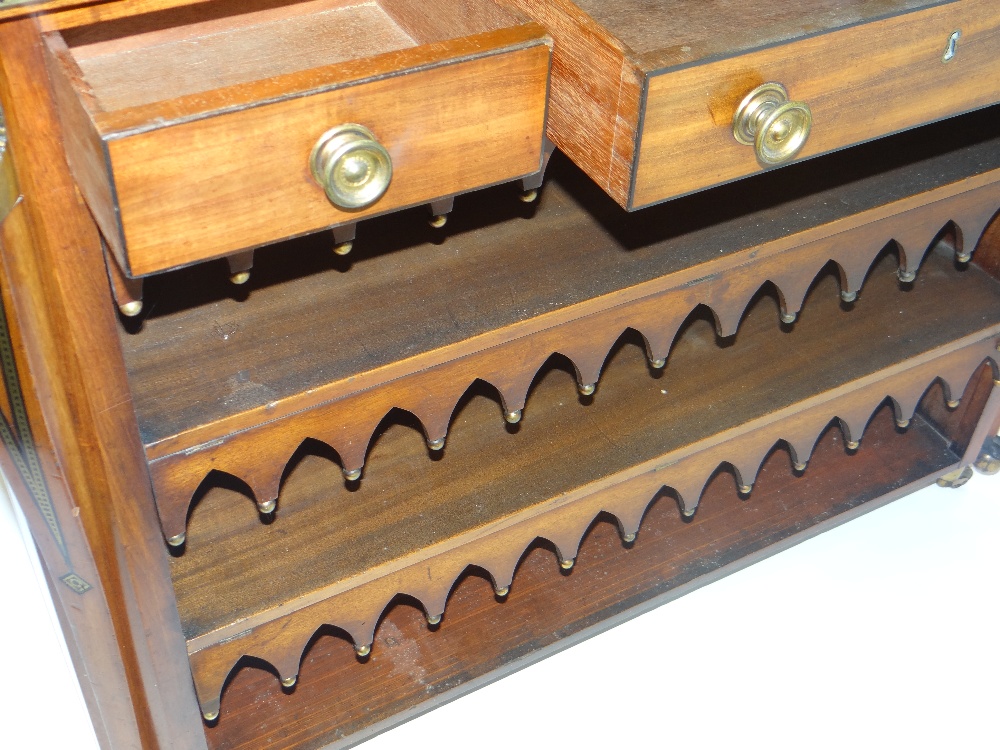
{"left": 309, "top": 123, "right": 392, "bottom": 209}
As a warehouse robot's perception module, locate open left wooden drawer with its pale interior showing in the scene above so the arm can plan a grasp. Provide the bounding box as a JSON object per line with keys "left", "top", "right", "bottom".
{"left": 46, "top": 0, "right": 550, "bottom": 277}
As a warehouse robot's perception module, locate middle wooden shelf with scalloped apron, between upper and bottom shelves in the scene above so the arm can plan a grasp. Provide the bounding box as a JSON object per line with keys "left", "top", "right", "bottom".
{"left": 171, "top": 243, "right": 1000, "bottom": 713}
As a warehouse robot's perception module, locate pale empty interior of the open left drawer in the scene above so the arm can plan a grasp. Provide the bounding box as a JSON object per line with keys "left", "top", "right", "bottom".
{"left": 57, "top": 0, "right": 517, "bottom": 112}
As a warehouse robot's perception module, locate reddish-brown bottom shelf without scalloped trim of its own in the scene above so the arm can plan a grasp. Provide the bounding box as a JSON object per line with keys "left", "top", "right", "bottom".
{"left": 205, "top": 366, "right": 993, "bottom": 750}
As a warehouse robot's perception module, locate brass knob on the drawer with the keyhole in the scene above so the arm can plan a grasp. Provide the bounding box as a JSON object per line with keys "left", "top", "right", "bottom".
{"left": 733, "top": 82, "right": 812, "bottom": 167}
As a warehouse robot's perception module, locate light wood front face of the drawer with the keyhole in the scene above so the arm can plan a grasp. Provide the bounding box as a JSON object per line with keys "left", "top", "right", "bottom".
{"left": 630, "top": 0, "right": 1000, "bottom": 208}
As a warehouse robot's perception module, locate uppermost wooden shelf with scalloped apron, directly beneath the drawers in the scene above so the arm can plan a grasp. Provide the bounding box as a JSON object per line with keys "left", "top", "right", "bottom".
{"left": 122, "top": 107, "right": 1000, "bottom": 537}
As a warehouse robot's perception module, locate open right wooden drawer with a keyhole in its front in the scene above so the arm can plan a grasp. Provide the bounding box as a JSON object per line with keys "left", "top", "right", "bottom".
{"left": 504, "top": 0, "right": 1000, "bottom": 210}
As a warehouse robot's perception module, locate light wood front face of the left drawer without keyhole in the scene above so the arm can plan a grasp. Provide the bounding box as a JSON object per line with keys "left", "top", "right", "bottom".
{"left": 107, "top": 43, "right": 549, "bottom": 276}
